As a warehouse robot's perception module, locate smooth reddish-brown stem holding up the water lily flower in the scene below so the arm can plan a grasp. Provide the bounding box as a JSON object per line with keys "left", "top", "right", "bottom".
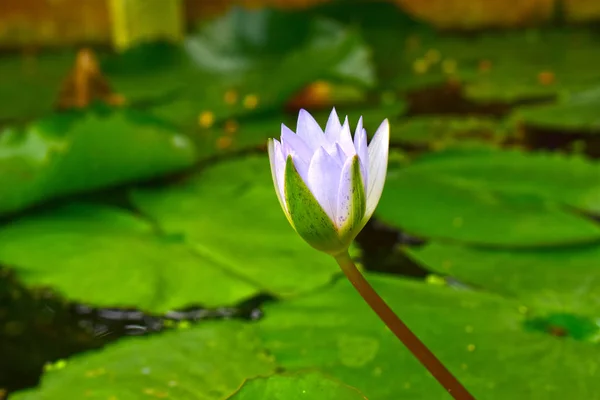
{"left": 335, "top": 252, "right": 475, "bottom": 400}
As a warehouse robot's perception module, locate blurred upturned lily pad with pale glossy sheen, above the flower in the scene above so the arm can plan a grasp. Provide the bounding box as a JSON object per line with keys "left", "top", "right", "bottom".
{"left": 140, "top": 7, "right": 374, "bottom": 129}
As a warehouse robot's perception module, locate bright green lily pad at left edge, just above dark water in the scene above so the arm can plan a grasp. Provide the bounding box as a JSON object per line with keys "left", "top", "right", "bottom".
{"left": 0, "top": 203, "right": 260, "bottom": 314}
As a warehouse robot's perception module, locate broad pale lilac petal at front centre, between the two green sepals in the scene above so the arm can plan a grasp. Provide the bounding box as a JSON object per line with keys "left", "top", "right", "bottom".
{"left": 308, "top": 147, "right": 342, "bottom": 223}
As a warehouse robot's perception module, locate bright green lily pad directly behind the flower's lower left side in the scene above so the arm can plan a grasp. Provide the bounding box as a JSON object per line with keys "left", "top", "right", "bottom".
{"left": 131, "top": 156, "right": 338, "bottom": 297}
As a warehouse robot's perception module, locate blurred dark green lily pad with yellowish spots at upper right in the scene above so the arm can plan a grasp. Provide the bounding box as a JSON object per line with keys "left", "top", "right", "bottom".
{"left": 396, "top": 29, "right": 600, "bottom": 103}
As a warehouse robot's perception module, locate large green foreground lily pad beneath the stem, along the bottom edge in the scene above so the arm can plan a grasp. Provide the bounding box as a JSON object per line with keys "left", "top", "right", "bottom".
{"left": 14, "top": 275, "right": 600, "bottom": 400}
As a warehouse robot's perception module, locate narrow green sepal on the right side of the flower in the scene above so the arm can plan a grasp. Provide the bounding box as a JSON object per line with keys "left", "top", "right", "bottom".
{"left": 339, "top": 155, "right": 367, "bottom": 242}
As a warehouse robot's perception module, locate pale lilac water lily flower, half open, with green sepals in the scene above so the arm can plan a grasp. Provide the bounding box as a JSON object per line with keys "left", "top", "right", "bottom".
{"left": 269, "top": 109, "right": 389, "bottom": 256}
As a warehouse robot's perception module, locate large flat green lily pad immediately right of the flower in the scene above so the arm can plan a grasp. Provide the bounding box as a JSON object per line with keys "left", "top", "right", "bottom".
{"left": 376, "top": 150, "right": 600, "bottom": 247}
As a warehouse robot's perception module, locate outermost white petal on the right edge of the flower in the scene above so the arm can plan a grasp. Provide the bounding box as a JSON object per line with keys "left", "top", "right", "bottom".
{"left": 365, "top": 119, "right": 390, "bottom": 219}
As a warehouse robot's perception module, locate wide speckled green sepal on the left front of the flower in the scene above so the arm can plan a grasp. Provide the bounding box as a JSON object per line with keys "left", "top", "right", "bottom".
{"left": 284, "top": 156, "right": 350, "bottom": 254}
